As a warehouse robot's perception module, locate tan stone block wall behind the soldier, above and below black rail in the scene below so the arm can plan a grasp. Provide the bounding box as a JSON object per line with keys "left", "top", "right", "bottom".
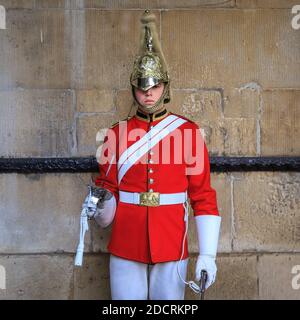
{"left": 0, "top": 0, "right": 300, "bottom": 299}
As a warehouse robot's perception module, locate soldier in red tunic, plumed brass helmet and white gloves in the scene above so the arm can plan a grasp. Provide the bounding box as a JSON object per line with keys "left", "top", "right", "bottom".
{"left": 82, "top": 10, "right": 221, "bottom": 300}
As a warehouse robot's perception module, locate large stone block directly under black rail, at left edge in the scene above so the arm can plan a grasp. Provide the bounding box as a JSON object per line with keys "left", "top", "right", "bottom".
{"left": 0, "top": 173, "right": 91, "bottom": 253}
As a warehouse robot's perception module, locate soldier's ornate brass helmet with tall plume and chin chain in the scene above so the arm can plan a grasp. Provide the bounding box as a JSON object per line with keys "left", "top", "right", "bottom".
{"left": 130, "top": 10, "right": 171, "bottom": 110}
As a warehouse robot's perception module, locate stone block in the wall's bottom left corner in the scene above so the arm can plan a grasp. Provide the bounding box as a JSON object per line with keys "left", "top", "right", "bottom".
{"left": 0, "top": 255, "right": 73, "bottom": 300}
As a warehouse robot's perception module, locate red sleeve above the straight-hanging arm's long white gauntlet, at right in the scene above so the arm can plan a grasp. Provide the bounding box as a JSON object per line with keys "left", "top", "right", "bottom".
{"left": 187, "top": 125, "right": 219, "bottom": 216}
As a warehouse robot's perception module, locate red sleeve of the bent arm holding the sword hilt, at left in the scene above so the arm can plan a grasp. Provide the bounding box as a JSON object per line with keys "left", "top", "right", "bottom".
{"left": 95, "top": 129, "right": 119, "bottom": 202}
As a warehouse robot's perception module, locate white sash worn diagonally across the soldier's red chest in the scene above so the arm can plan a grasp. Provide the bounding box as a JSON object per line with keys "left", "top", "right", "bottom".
{"left": 118, "top": 115, "right": 187, "bottom": 184}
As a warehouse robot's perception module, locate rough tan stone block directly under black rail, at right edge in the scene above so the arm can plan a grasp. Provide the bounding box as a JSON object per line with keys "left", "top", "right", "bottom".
{"left": 233, "top": 172, "right": 300, "bottom": 252}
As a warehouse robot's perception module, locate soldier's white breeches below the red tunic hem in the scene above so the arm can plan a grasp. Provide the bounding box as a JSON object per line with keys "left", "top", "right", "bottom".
{"left": 109, "top": 254, "right": 188, "bottom": 300}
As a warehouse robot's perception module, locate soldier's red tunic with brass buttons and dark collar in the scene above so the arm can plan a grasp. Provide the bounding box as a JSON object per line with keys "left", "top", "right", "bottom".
{"left": 95, "top": 112, "right": 219, "bottom": 264}
